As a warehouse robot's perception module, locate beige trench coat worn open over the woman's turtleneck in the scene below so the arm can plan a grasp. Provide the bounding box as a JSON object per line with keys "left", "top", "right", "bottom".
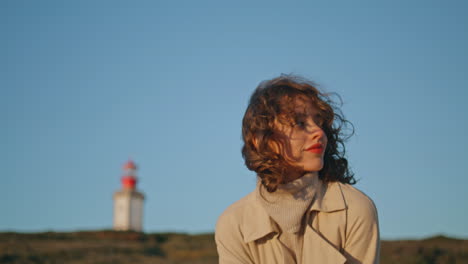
{"left": 215, "top": 182, "right": 380, "bottom": 264}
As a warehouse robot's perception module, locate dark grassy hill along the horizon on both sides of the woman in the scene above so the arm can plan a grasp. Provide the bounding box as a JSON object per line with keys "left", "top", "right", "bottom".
{"left": 0, "top": 231, "right": 468, "bottom": 264}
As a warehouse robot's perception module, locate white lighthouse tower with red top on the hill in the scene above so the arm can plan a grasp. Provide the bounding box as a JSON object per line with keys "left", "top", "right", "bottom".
{"left": 114, "top": 160, "right": 145, "bottom": 232}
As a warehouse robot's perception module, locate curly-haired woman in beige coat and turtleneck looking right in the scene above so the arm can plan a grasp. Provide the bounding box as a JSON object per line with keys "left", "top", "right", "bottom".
{"left": 215, "top": 76, "right": 380, "bottom": 264}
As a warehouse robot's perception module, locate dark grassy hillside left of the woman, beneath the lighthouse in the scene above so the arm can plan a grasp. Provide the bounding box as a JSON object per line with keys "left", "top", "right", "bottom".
{"left": 0, "top": 231, "right": 217, "bottom": 264}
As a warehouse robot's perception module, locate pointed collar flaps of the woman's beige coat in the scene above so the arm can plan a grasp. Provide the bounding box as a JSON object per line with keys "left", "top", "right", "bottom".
{"left": 242, "top": 179, "right": 346, "bottom": 243}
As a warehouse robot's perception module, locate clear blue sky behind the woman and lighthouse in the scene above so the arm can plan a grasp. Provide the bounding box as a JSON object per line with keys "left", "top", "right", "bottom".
{"left": 0, "top": 0, "right": 468, "bottom": 239}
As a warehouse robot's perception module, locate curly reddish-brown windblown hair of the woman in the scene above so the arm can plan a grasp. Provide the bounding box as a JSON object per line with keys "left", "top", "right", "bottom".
{"left": 242, "top": 75, "right": 356, "bottom": 192}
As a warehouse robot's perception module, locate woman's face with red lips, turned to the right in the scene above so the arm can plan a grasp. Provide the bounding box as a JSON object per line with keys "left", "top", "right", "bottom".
{"left": 272, "top": 97, "right": 327, "bottom": 176}
